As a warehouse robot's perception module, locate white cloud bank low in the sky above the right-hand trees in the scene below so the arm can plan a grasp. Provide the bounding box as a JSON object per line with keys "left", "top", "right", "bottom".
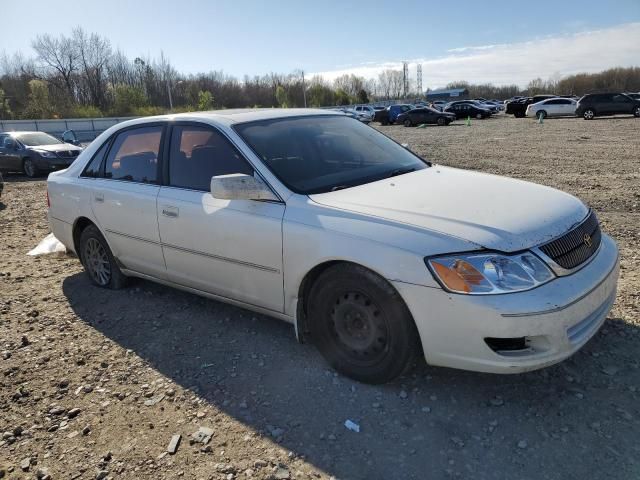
{"left": 315, "top": 23, "right": 640, "bottom": 89}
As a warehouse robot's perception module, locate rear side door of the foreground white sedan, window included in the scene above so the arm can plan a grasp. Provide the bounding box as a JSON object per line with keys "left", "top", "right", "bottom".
{"left": 91, "top": 124, "right": 166, "bottom": 278}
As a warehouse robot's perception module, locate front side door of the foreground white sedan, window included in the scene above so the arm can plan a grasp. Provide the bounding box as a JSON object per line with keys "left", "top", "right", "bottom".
{"left": 157, "top": 123, "right": 285, "bottom": 312}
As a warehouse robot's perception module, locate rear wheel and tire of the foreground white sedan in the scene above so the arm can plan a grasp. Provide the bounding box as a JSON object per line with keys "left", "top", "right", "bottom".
{"left": 79, "top": 225, "right": 127, "bottom": 290}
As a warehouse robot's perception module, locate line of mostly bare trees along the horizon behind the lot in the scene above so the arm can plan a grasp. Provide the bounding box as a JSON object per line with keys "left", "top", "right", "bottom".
{"left": 0, "top": 27, "right": 640, "bottom": 119}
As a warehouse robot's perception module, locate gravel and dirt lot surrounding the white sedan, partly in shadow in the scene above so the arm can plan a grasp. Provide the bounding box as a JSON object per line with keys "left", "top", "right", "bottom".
{"left": 0, "top": 113, "right": 640, "bottom": 480}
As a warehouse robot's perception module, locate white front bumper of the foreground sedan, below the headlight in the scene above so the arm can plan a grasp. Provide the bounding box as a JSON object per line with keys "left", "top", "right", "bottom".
{"left": 393, "top": 235, "right": 619, "bottom": 373}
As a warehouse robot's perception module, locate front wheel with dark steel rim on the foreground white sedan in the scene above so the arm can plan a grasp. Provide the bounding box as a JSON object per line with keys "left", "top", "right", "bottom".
{"left": 307, "top": 264, "right": 420, "bottom": 384}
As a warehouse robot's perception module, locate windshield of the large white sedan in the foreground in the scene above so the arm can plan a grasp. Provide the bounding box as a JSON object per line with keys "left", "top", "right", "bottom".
{"left": 234, "top": 115, "right": 429, "bottom": 195}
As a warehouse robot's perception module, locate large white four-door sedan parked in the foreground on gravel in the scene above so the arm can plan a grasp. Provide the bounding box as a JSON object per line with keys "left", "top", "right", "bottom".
{"left": 48, "top": 109, "right": 618, "bottom": 383}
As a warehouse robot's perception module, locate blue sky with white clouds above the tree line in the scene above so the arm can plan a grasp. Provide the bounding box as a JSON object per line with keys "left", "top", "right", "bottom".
{"left": 0, "top": 0, "right": 640, "bottom": 89}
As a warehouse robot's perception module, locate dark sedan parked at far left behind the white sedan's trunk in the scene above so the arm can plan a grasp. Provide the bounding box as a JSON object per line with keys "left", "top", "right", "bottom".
{"left": 0, "top": 132, "right": 82, "bottom": 178}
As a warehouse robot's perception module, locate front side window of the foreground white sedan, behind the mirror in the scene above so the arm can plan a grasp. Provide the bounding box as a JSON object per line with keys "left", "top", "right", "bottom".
{"left": 169, "top": 125, "right": 253, "bottom": 192}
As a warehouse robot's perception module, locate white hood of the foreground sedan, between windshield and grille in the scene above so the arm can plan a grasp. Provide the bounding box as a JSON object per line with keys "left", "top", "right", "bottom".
{"left": 310, "top": 165, "right": 588, "bottom": 252}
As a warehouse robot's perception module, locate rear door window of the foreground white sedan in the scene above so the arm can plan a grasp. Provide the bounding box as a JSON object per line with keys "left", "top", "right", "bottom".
{"left": 104, "top": 126, "right": 162, "bottom": 183}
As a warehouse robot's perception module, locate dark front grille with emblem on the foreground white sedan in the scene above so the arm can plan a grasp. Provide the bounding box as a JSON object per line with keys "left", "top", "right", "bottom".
{"left": 540, "top": 211, "right": 601, "bottom": 269}
